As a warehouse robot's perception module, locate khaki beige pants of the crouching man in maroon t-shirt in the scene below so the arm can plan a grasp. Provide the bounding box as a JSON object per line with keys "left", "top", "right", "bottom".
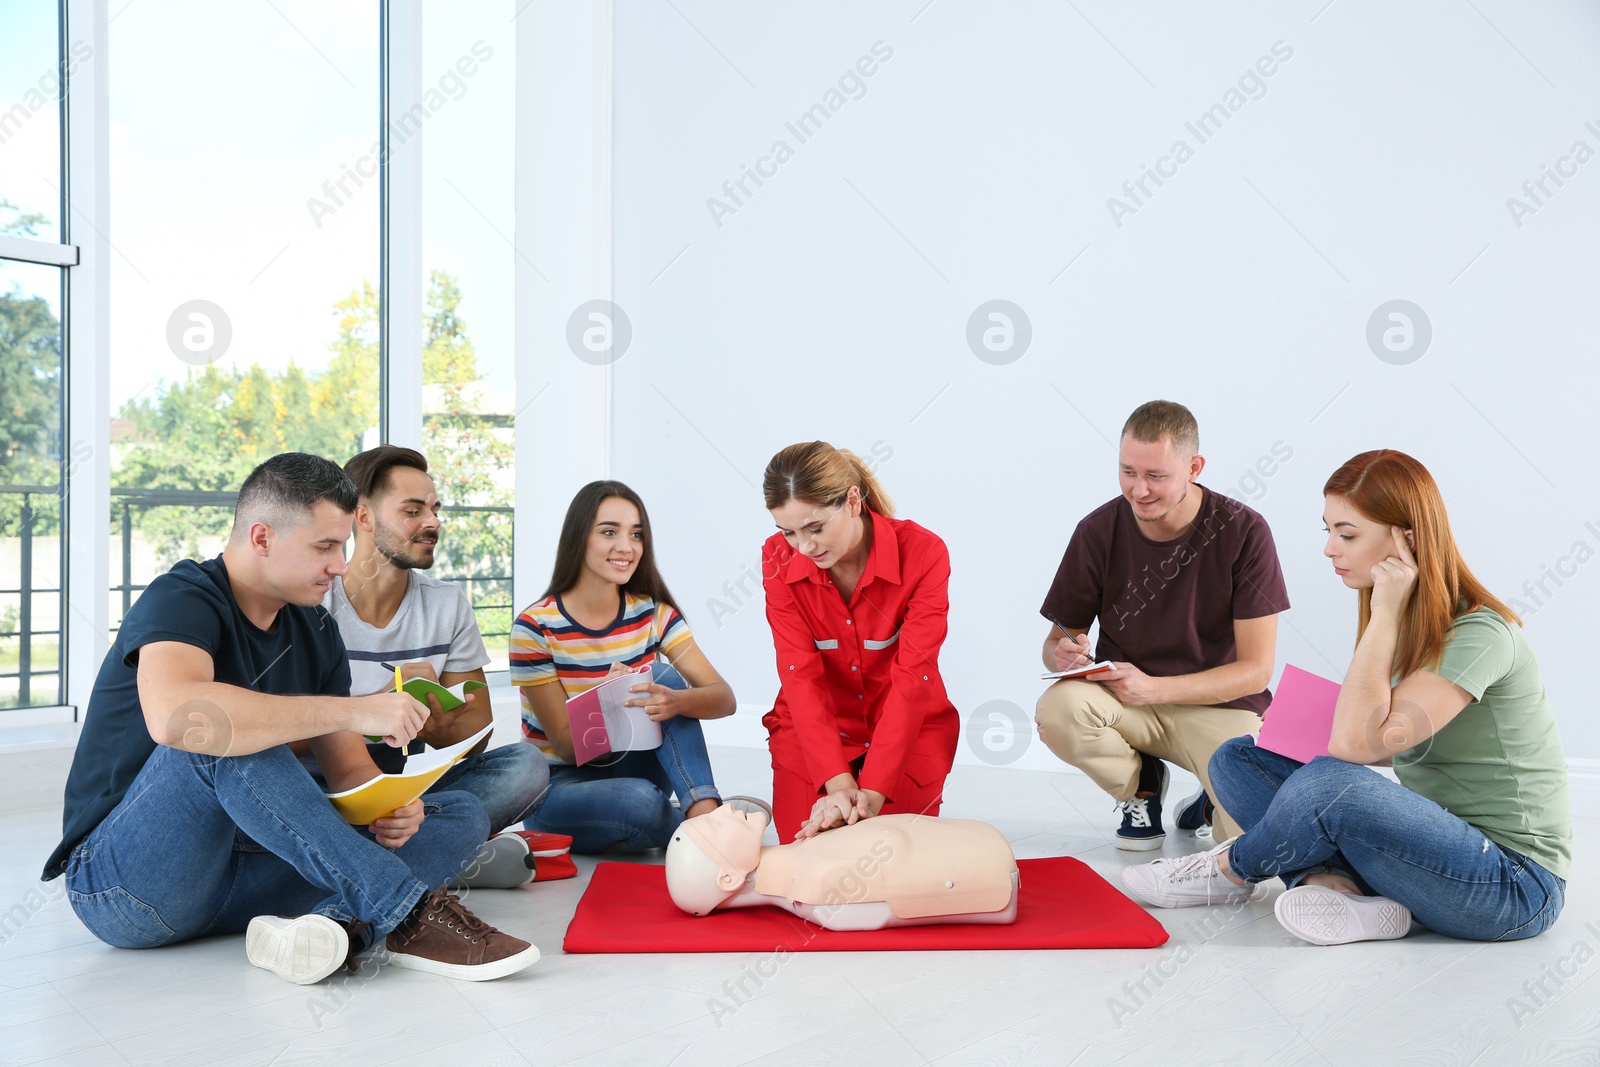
{"left": 1035, "top": 678, "right": 1261, "bottom": 845}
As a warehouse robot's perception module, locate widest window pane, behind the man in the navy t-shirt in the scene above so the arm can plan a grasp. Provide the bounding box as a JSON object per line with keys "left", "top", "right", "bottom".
{"left": 109, "top": 0, "right": 381, "bottom": 627}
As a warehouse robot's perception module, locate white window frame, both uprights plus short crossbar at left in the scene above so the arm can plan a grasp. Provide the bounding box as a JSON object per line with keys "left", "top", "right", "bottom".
{"left": 0, "top": 0, "right": 486, "bottom": 721}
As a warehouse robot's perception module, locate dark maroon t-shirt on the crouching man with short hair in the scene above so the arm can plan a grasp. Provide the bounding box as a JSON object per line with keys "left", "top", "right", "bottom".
{"left": 1040, "top": 483, "right": 1290, "bottom": 715}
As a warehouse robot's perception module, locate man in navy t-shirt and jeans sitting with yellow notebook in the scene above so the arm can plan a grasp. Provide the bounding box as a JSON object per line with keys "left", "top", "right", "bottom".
{"left": 45, "top": 453, "right": 539, "bottom": 984}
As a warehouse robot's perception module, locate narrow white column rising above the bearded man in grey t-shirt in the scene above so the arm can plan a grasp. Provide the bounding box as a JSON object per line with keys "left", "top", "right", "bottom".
{"left": 382, "top": 0, "right": 424, "bottom": 448}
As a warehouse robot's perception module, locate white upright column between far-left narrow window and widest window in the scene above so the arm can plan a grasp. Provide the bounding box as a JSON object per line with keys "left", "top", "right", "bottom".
{"left": 62, "top": 0, "right": 110, "bottom": 717}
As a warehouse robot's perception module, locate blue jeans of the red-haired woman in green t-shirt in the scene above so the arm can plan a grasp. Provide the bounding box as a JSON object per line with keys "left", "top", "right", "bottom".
{"left": 1211, "top": 737, "right": 1566, "bottom": 941}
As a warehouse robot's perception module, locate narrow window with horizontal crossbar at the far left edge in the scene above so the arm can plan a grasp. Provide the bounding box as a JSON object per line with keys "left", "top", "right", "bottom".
{"left": 0, "top": 0, "right": 74, "bottom": 707}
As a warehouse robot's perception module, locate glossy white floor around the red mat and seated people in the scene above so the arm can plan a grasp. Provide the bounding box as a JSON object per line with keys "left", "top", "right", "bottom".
{"left": 0, "top": 749, "right": 1600, "bottom": 1067}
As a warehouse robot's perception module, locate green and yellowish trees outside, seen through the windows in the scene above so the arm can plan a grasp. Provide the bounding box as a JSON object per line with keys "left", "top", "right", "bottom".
{"left": 0, "top": 255, "right": 512, "bottom": 671}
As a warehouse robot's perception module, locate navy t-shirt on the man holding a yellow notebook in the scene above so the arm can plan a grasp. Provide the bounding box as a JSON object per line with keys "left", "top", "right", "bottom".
{"left": 45, "top": 557, "right": 350, "bottom": 880}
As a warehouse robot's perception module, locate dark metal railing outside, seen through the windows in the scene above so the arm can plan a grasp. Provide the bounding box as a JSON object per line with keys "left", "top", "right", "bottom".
{"left": 0, "top": 485, "right": 514, "bottom": 709}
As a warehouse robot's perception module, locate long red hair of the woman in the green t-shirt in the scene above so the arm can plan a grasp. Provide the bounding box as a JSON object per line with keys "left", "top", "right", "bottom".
{"left": 1322, "top": 448, "right": 1522, "bottom": 677}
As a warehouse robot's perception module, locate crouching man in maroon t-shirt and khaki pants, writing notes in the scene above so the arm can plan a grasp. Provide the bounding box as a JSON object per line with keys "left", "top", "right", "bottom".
{"left": 1037, "top": 400, "right": 1290, "bottom": 851}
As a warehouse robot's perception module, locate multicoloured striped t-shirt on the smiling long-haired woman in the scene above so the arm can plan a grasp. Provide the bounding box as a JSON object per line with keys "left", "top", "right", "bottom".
{"left": 510, "top": 592, "right": 693, "bottom": 763}
